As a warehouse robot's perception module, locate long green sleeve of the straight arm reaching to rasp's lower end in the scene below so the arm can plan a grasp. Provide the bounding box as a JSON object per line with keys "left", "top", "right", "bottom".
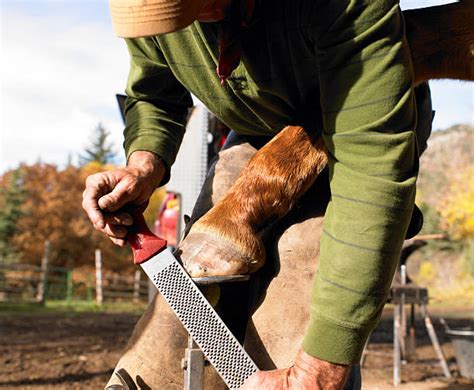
{"left": 303, "top": 0, "right": 418, "bottom": 364}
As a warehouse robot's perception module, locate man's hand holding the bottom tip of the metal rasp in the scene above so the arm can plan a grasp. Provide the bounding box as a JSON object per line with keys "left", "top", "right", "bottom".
{"left": 241, "top": 351, "right": 350, "bottom": 390}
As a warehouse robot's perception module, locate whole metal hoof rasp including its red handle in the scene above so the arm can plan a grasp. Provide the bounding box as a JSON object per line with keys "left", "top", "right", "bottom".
{"left": 127, "top": 214, "right": 258, "bottom": 389}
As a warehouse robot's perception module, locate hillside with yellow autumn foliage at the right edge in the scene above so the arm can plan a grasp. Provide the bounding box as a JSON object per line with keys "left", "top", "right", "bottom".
{"left": 408, "top": 125, "right": 474, "bottom": 305}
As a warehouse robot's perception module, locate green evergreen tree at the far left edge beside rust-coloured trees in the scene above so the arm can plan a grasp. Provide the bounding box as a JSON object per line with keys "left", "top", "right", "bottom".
{"left": 0, "top": 169, "right": 25, "bottom": 259}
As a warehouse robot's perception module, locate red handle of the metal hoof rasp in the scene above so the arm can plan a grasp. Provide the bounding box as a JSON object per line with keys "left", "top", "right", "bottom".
{"left": 127, "top": 213, "right": 166, "bottom": 264}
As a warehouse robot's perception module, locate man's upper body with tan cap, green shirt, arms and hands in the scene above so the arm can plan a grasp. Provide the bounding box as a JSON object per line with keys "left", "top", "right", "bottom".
{"left": 84, "top": 0, "right": 424, "bottom": 389}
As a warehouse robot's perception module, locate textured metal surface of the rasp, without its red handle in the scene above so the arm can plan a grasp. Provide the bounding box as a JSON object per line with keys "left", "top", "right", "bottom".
{"left": 151, "top": 261, "right": 258, "bottom": 389}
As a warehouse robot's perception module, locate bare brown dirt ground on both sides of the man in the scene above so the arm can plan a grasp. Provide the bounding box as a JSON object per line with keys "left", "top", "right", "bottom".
{"left": 0, "top": 306, "right": 474, "bottom": 390}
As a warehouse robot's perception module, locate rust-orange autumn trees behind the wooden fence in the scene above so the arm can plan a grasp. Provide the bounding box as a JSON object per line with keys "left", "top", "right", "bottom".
{"left": 11, "top": 163, "right": 133, "bottom": 270}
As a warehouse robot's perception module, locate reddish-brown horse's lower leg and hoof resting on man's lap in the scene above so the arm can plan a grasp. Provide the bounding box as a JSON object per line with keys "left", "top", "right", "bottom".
{"left": 180, "top": 126, "right": 327, "bottom": 277}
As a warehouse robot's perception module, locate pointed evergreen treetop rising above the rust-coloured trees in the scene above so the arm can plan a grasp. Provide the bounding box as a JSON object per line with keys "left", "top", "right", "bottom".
{"left": 79, "top": 123, "right": 116, "bottom": 166}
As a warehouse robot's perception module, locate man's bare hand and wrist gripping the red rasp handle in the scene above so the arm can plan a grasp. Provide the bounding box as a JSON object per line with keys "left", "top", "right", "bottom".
{"left": 82, "top": 151, "right": 165, "bottom": 246}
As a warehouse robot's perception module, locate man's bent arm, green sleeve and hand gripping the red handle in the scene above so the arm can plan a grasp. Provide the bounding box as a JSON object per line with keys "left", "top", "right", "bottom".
{"left": 83, "top": 38, "right": 192, "bottom": 242}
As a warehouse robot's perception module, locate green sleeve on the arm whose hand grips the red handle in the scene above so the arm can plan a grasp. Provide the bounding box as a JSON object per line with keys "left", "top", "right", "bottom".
{"left": 124, "top": 37, "right": 193, "bottom": 182}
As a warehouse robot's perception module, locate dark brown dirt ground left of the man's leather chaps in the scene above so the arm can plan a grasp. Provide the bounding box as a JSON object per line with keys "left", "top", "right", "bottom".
{"left": 0, "top": 313, "right": 138, "bottom": 389}
